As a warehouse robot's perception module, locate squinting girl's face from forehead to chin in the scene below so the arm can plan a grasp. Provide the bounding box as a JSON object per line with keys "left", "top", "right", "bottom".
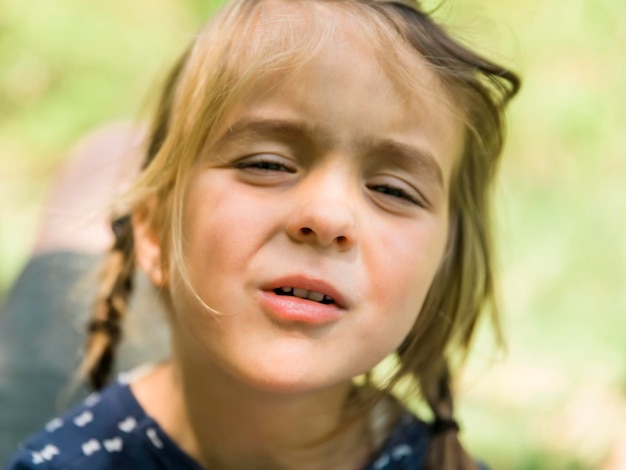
{"left": 154, "top": 26, "right": 463, "bottom": 393}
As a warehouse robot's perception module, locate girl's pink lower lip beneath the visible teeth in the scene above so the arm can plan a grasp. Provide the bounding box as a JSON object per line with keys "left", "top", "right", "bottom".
{"left": 260, "top": 291, "right": 344, "bottom": 326}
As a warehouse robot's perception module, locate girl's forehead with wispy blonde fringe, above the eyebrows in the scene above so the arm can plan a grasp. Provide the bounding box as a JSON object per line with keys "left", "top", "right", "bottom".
{"left": 184, "top": 0, "right": 465, "bottom": 184}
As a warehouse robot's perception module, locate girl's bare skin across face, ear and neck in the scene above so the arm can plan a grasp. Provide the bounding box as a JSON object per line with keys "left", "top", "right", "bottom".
{"left": 133, "top": 7, "right": 463, "bottom": 469}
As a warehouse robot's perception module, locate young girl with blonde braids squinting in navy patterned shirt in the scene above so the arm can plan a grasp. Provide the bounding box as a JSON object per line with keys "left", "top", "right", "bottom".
{"left": 9, "top": 0, "right": 519, "bottom": 470}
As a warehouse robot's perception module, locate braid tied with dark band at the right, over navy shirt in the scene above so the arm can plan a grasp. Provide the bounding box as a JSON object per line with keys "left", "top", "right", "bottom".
{"left": 422, "top": 366, "right": 477, "bottom": 470}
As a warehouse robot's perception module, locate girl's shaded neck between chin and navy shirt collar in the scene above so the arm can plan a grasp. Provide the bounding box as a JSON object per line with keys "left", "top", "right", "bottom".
{"left": 133, "top": 360, "right": 370, "bottom": 470}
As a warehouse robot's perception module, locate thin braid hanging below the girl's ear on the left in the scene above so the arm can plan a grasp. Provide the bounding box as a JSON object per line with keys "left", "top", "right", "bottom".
{"left": 81, "top": 216, "right": 135, "bottom": 390}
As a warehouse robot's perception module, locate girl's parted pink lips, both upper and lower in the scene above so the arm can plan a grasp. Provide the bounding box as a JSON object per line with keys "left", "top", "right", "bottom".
{"left": 259, "top": 276, "right": 347, "bottom": 326}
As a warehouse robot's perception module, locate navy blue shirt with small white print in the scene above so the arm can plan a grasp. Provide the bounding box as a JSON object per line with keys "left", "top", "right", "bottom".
{"left": 6, "top": 383, "right": 429, "bottom": 470}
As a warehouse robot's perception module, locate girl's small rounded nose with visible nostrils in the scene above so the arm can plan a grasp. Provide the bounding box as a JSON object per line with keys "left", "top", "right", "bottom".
{"left": 287, "top": 169, "right": 356, "bottom": 251}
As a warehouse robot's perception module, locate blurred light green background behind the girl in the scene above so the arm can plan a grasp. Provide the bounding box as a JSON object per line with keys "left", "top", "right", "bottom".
{"left": 0, "top": 0, "right": 626, "bottom": 470}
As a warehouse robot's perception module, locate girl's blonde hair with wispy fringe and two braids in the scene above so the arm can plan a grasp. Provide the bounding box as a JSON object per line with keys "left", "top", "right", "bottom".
{"left": 83, "top": 0, "right": 520, "bottom": 469}
